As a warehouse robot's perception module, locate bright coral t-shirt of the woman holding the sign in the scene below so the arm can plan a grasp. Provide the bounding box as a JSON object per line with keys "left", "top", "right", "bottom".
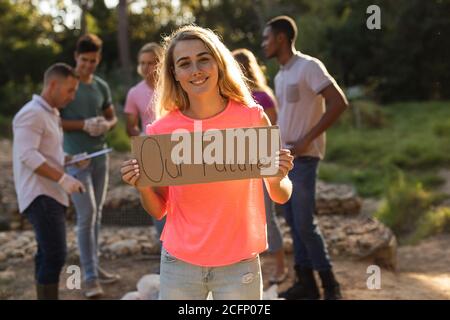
{"left": 146, "top": 100, "right": 267, "bottom": 267}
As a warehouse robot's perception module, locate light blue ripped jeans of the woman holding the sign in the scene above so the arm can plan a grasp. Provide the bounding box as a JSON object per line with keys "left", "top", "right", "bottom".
{"left": 159, "top": 248, "right": 263, "bottom": 300}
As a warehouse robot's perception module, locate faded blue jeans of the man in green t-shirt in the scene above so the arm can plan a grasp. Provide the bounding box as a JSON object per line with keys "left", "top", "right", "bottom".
{"left": 67, "top": 155, "right": 109, "bottom": 281}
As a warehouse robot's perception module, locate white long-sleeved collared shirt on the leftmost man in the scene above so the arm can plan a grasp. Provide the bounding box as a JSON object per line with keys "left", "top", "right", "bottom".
{"left": 13, "top": 95, "right": 69, "bottom": 213}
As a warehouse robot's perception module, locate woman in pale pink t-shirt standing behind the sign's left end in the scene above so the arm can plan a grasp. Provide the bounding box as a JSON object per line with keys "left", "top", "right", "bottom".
{"left": 124, "top": 42, "right": 162, "bottom": 136}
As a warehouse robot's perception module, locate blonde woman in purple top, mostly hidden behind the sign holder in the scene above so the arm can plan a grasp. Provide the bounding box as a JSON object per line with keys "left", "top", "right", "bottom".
{"left": 232, "top": 49, "right": 288, "bottom": 284}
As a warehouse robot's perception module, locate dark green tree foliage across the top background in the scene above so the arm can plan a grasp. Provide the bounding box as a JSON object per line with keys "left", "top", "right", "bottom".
{"left": 0, "top": 0, "right": 450, "bottom": 117}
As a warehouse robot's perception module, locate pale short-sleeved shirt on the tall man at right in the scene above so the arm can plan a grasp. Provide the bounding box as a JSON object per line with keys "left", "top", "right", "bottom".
{"left": 275, "top": 52, "right": 335, "bottom": 159}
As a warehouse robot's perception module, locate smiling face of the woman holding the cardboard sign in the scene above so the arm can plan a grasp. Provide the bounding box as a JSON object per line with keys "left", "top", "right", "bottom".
{"left": 173, "top": 40, "right": 219, "bottom": 96}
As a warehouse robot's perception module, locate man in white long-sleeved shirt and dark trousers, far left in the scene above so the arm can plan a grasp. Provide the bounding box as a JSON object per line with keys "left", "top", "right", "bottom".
{"left": 13, "top": 63, "right": 86, "bottom": 300}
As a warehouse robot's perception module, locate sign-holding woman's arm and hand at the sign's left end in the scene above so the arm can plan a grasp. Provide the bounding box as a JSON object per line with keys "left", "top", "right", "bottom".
{"left": 120, "top": 159, "right": 169, "bottom": 220}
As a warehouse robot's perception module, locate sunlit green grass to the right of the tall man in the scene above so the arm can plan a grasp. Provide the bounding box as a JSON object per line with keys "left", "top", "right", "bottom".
{"left": 319, "top": 101, "right": 450, "bottom": 243}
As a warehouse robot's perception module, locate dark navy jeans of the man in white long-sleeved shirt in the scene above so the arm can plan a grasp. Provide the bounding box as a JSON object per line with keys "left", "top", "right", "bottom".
{"left": 23, "top": 195, "right": 67, "bottom": 284}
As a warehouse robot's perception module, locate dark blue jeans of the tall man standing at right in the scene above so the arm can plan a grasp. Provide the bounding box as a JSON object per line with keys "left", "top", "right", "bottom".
{"left": 283, "top": 157, "right": 331, "bottom": 271}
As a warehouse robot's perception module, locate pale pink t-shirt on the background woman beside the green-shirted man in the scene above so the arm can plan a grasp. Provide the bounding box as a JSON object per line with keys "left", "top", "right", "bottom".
{"left": 123, "top": 80, "right": 155, "bottom": 132}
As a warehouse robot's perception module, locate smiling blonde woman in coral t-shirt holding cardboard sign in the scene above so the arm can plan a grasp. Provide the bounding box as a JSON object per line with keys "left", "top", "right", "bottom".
{"left": 121, "top": 26, "right": 293, "bottom": 299}
